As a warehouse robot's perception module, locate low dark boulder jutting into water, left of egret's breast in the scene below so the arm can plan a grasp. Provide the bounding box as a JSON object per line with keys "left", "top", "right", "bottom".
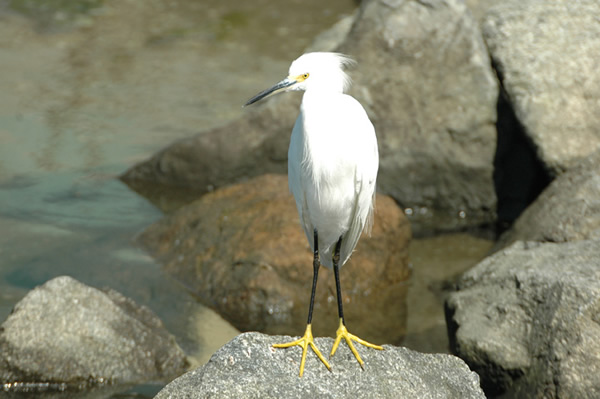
{"left": 121, "top": 93, "right": 301, "bottom": 211}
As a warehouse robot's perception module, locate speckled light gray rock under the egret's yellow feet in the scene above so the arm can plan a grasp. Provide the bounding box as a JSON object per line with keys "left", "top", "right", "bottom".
{"left": 156, "top": 333, "right": 485, "bottom": 399}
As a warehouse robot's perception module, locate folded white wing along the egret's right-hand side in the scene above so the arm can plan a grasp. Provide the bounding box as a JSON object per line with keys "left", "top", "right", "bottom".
{"left": 340, "top": 118, "right": 379, "bottom": 264}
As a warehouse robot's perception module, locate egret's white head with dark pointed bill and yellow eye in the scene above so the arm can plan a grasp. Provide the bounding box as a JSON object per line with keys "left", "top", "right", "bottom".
{"left": 244, "top": 52, "right": 354, "bottom": 106}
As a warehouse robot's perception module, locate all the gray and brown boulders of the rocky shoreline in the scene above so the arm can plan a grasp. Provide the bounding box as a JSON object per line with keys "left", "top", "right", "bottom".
{"left": 0, "top": 0, "right": 600, "bottom": 398}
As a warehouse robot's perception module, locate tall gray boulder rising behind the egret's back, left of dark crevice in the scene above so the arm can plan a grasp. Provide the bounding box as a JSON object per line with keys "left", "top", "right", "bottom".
{"left": 340, "top": 0, "right": 498, "bottom": 230}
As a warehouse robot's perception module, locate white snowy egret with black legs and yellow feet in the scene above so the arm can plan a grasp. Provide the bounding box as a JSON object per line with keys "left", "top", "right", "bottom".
{"left": 246, "top": 53, "right": 383, "bottom": 376}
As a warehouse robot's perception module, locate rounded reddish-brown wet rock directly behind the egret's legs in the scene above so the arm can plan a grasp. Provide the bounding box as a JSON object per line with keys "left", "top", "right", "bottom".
{"left": 140, "top": 175, "right": 411, "bottom": 343}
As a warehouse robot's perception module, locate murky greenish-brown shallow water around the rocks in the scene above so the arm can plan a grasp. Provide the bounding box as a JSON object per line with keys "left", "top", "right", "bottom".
{"left": 0, "top": 0, "right": 489, "bottom": 397}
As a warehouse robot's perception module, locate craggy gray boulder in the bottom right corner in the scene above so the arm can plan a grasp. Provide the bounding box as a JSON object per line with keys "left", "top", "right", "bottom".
{"left": 446, "top": 240, "right": 600, "bottom": 398}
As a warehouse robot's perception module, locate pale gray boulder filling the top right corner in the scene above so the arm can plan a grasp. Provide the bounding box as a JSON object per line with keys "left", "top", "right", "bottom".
{"left": 483, "top": 0, "right": 600, "bottom": 175}
